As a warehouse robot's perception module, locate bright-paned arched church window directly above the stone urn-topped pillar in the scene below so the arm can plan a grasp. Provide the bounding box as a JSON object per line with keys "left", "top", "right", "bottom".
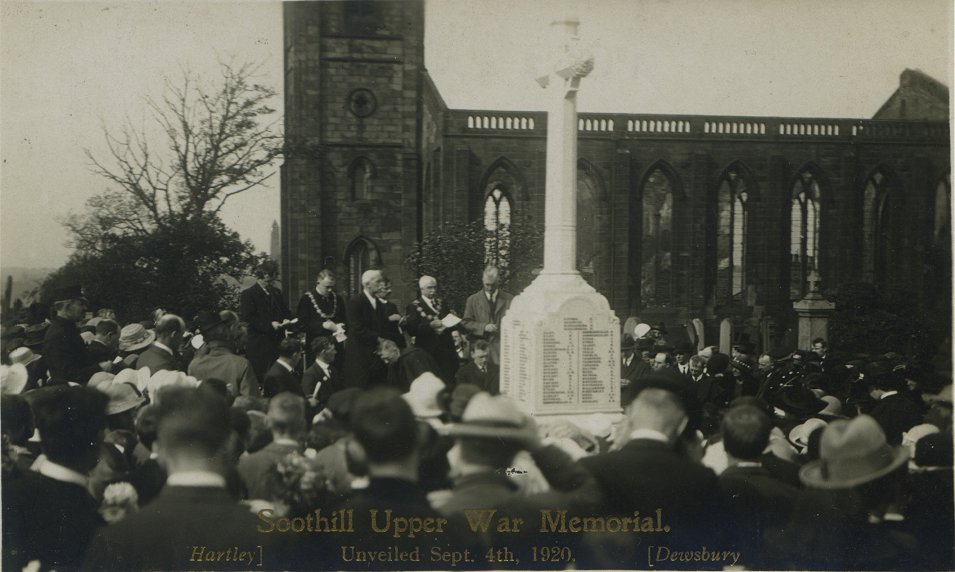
{"left": 789, "top": 171, "right": 821, "bottom": 300}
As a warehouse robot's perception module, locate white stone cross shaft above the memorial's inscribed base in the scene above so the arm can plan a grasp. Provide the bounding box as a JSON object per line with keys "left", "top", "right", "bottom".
{"left": 537, "top": 18, "right": 594, "bottom": 275}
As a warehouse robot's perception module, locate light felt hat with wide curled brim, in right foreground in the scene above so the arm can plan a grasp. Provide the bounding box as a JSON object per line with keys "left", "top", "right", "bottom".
{"left": 799, "top": 415, "right": 909, "bottom": 489}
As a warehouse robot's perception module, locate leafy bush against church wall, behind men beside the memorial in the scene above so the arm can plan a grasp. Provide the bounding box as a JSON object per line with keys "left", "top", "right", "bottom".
{"left": 405, "top": 219, "right": 544, "bottom": 314}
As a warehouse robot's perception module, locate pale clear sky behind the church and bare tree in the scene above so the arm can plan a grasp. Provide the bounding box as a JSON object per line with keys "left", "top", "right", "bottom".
{"left": 0, "top": 0, "right": 955, "bottom": 268}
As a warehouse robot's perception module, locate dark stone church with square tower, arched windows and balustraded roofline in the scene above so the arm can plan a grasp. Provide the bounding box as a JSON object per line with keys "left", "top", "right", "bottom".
{"left": 281, "top": 1, "right": 951, "bottom": 358}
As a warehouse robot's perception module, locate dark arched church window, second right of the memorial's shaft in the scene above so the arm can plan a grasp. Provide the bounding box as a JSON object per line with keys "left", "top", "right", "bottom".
{"left": 640, "top": 169, "right": 673, "bottom": 306}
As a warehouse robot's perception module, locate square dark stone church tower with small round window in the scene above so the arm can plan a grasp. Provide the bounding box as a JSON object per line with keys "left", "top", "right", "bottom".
{"left": 281, "top": 0, "right": 425, "bottom": 304}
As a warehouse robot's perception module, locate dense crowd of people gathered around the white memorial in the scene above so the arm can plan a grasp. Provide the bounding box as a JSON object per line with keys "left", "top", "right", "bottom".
{"left": 0, "top": 264, "right": 955, "bottom": 570}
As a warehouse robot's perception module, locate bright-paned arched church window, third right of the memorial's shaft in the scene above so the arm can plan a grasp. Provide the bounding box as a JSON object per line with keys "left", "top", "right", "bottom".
{"left": 716, "top": 170, "right": 749, "bottom": 303}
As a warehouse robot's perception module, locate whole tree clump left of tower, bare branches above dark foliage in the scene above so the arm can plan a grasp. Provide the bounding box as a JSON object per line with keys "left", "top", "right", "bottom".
{"left": 42, "top": 63, "right": 282, "bottom": 320}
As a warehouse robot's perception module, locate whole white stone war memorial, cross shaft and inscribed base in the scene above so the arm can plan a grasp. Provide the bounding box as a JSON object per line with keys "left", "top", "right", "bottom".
{"left": 501, "top": 19, "right": 620, "bottom": 417}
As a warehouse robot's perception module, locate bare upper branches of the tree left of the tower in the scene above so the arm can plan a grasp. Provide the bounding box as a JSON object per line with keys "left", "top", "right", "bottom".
{"left": 65, "top": 59, "right": 282, "bottom": 252}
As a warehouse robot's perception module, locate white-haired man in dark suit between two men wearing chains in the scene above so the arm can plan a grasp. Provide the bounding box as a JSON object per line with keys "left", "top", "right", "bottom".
{"left": 344, "top": 270, "right": 388, "bottom": 389}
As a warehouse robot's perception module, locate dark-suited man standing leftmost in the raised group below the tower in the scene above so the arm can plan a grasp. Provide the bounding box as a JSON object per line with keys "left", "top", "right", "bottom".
{"left": 239, "top": 260, "right": 292, "bottom": 379}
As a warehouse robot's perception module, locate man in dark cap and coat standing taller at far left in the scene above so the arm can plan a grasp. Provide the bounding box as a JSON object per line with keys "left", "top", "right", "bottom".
{"left": 43, "top": 286, "right": 112, "bottom": 384}
